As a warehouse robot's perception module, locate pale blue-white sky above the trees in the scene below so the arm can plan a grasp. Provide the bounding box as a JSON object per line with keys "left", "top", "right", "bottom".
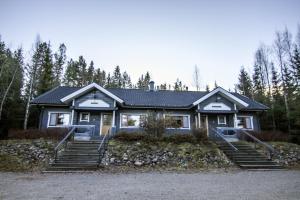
{"left": 0, "top": 0, "right": 300, "bottom": 89}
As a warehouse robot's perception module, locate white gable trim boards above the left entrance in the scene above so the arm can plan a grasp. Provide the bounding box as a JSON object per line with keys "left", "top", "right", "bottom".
{"left": 60, "top": 83, "right": 124, "bottom": 103}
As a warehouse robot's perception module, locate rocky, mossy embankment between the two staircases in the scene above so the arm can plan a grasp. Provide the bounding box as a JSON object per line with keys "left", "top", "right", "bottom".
{"left": 102, "top": 140, "right": 233, "bottom": 169}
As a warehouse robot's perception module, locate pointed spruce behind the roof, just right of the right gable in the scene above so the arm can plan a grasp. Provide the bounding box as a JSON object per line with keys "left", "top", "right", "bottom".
{"left": 237, "top": 67, "right": 253, "bottom": 98}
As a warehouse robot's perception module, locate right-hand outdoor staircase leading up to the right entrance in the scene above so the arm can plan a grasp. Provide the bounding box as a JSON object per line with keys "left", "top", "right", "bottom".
{"left": 218, "top": 142, "right": 283, "bottom": 170}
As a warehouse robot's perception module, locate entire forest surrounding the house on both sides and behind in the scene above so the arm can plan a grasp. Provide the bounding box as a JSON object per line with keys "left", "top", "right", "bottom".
{"left": 0, "top": 26, "right": 300, "bottom": 138}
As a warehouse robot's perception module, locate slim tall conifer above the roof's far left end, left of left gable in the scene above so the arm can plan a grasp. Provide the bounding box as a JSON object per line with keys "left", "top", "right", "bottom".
{"left": 53, "top": 44, "right": 66, "bottom": 86}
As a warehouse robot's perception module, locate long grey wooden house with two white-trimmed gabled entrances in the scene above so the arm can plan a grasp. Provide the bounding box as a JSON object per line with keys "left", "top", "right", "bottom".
{"left": 31, "top": 81, "right": 268, "bottom": 138}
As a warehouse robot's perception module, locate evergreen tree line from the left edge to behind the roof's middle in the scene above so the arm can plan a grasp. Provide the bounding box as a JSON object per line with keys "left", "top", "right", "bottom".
{"left": 0, "top": 36, "right": 187, "bottom": 137}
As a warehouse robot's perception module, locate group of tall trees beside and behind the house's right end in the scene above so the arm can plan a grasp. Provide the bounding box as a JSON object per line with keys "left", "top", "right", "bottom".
{"left": 236, "top": 26, "right": 300, "bottom": 132}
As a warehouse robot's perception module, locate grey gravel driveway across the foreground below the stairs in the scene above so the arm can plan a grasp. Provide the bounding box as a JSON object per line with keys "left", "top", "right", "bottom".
{"left": 0, "top": 171, "right": 300, "bottom": 200}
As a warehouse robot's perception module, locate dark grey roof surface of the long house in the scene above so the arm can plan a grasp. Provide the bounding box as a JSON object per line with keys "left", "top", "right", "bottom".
{"left": 31, "top": 86, "right": 268, "bottom": 110}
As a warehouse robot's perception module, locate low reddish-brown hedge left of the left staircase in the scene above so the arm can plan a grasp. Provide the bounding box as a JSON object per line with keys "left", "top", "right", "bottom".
{"left": 8, "top": 128, "right": 68, "bottom": 140}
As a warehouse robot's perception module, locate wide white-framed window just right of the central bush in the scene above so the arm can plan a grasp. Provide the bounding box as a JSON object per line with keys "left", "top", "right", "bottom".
{"left": 165, "top": 115, "right": 190, "bottom": 129}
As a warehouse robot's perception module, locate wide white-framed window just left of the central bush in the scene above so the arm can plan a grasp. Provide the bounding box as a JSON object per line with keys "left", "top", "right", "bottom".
{"left": 121, "top": 114, "right": 146, "bottom": 128}
